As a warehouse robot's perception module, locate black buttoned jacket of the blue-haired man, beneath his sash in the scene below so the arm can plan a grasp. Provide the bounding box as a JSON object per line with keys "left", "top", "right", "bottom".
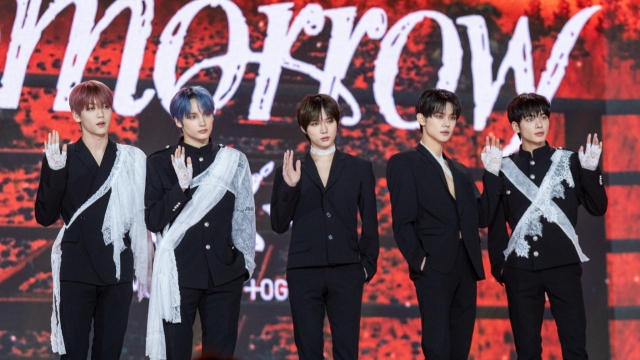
{"left": 144, "top": 141, "right": 248, "bottom": 289}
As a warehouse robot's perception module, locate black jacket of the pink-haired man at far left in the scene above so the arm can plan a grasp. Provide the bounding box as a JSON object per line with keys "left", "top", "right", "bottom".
{"left": 35, "top": 139, "right": 133, "bottom": 286}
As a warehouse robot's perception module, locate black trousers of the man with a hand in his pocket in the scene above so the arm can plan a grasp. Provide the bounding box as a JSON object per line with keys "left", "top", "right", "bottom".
{"left": 412, "top": 240, "right": 477, "bottom": 360}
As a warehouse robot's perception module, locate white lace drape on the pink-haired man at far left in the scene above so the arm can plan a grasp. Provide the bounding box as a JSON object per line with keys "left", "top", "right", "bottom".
{"left": 51, "top": 144, "right": 153, "bottom": 355}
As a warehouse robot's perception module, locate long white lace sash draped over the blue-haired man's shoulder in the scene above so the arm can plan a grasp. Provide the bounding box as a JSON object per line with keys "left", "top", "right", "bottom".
{"left": 146, "top": 147, "right": 256, "bottom": 360}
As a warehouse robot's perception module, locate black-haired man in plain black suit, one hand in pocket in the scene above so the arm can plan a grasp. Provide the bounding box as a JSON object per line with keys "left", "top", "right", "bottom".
{"left": 387, "top": 89, "right": 502, "bottom": 360}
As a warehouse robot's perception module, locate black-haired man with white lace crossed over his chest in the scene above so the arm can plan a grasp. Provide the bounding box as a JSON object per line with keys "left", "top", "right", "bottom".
{"left": 489, "top": 94, "right": 607, "bottom": 359}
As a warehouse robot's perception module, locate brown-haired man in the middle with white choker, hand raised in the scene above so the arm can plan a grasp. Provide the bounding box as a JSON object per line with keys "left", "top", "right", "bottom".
{"left": 271, "top": 94, "right": 379, "bottom": 359}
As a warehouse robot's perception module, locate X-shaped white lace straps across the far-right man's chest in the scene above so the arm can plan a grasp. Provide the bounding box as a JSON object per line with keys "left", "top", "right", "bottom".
{"left": 502, "top": 149, "right": 589, "bottom": 262}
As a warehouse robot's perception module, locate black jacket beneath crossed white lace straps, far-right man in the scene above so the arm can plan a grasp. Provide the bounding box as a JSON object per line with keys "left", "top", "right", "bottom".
{"left": 489, "top": 144, "right": 608, "bottom": 282}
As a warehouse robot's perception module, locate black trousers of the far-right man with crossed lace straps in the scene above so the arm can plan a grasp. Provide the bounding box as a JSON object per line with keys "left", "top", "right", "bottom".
{"left": 502, "top": 264, "right": 587, "bottom": 360}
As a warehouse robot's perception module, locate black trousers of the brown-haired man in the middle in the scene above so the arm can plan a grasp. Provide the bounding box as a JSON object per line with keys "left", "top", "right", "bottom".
{"left": 287, "top": 263, "right": 365, "bottom": 360}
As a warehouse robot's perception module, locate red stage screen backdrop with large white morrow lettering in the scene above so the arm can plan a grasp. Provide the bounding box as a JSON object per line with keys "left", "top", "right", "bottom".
{"left": 0, "top": 0, "right": 640, "bottom": 359}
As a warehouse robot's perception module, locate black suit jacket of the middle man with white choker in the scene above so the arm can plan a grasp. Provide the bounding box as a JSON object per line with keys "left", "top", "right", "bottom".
{"left": 271, "top": 150, "right": 380, "bottom": 280}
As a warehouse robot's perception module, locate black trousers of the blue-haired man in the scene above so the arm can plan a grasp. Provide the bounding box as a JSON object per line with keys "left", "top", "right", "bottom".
{"left": 163, "top": 269, "right": 245, "bottom": 360}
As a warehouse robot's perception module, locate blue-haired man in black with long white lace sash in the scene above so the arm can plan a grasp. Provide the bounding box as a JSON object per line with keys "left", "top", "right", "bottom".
{"left": 145, "top": 86, "right": 256, "bottom": 359}
